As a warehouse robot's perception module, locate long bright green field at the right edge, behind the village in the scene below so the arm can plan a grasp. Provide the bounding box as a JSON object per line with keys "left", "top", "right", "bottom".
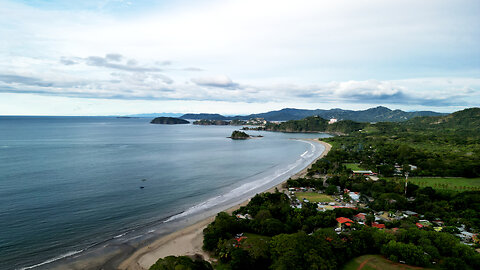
{"left": 393, "top": 177, "right": 480, "bottom": 191}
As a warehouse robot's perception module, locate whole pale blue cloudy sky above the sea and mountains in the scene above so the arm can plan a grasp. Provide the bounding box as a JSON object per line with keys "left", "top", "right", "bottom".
{"left": 0, "top": 0, "right": 480, "bottom": 115}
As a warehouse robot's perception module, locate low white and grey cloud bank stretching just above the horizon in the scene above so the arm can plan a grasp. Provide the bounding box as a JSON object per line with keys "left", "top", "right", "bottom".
{"left": 0, "top": 70, "right": 480, "bottom": 107}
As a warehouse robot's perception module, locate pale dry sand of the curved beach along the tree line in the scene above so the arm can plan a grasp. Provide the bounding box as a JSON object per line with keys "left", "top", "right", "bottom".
{"left": 118, "top": 139, "right": 332, "bottom": 270}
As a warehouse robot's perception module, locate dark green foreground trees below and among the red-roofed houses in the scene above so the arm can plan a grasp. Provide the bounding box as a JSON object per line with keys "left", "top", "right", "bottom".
{"left": 204, "top": 188, "right": 480, "bottom": 269}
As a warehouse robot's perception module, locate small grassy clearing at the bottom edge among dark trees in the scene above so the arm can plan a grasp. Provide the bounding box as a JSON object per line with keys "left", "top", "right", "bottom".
{"left": 343, "top": 255, "right": 425, "bottom": 270}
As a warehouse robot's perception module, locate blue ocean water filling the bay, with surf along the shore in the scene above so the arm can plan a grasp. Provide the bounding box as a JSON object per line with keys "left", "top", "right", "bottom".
{"left": 0, "top": 117, "right": 327, "bottom": 269}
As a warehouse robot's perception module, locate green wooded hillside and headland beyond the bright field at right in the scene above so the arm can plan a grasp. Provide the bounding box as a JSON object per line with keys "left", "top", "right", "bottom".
{"left": 282, "top": 108, "right": 480, "bottom": 177}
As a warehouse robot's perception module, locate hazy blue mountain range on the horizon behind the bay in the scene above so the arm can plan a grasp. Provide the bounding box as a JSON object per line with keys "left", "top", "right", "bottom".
{"left": 180, "top": 106, "right": 445, "bottom": 122}
